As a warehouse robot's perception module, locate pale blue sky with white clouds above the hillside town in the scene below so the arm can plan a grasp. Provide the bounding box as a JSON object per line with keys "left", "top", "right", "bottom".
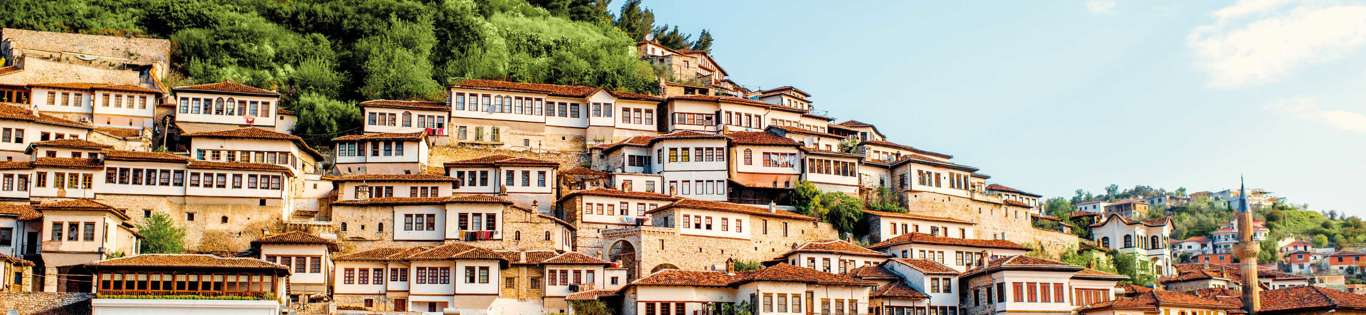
{"left": 636, "top": 0, "right": 1366, "bottom": 217}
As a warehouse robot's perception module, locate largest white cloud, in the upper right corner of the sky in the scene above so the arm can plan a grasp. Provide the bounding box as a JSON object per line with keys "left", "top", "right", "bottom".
{"left": 1187, "top": 0, "right": 1366, "bottom": 87}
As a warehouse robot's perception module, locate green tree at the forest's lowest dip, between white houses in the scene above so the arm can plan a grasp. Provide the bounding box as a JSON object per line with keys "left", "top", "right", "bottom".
{"left": 294, "top": 93, "right": 361, "bottom": 143}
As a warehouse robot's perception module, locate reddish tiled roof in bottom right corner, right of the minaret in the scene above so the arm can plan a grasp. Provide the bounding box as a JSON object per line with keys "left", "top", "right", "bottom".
{"left": 1257, "top": 286, "right": 1366, "bottom": 314}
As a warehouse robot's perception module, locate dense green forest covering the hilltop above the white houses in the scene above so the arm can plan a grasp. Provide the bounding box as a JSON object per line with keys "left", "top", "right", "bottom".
{"left": 0, "top": 0, "right": 713, "bottom": 143}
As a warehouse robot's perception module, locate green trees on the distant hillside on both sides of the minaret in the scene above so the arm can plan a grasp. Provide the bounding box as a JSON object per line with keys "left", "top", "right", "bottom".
{"left": 1045, "top": 184, "right": 1366, "bottom": 262}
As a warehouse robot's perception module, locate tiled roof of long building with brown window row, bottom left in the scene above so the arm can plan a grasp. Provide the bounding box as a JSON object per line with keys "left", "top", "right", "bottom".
{"left": 90, "top": 254, "right": 290, "bottom": 273}
